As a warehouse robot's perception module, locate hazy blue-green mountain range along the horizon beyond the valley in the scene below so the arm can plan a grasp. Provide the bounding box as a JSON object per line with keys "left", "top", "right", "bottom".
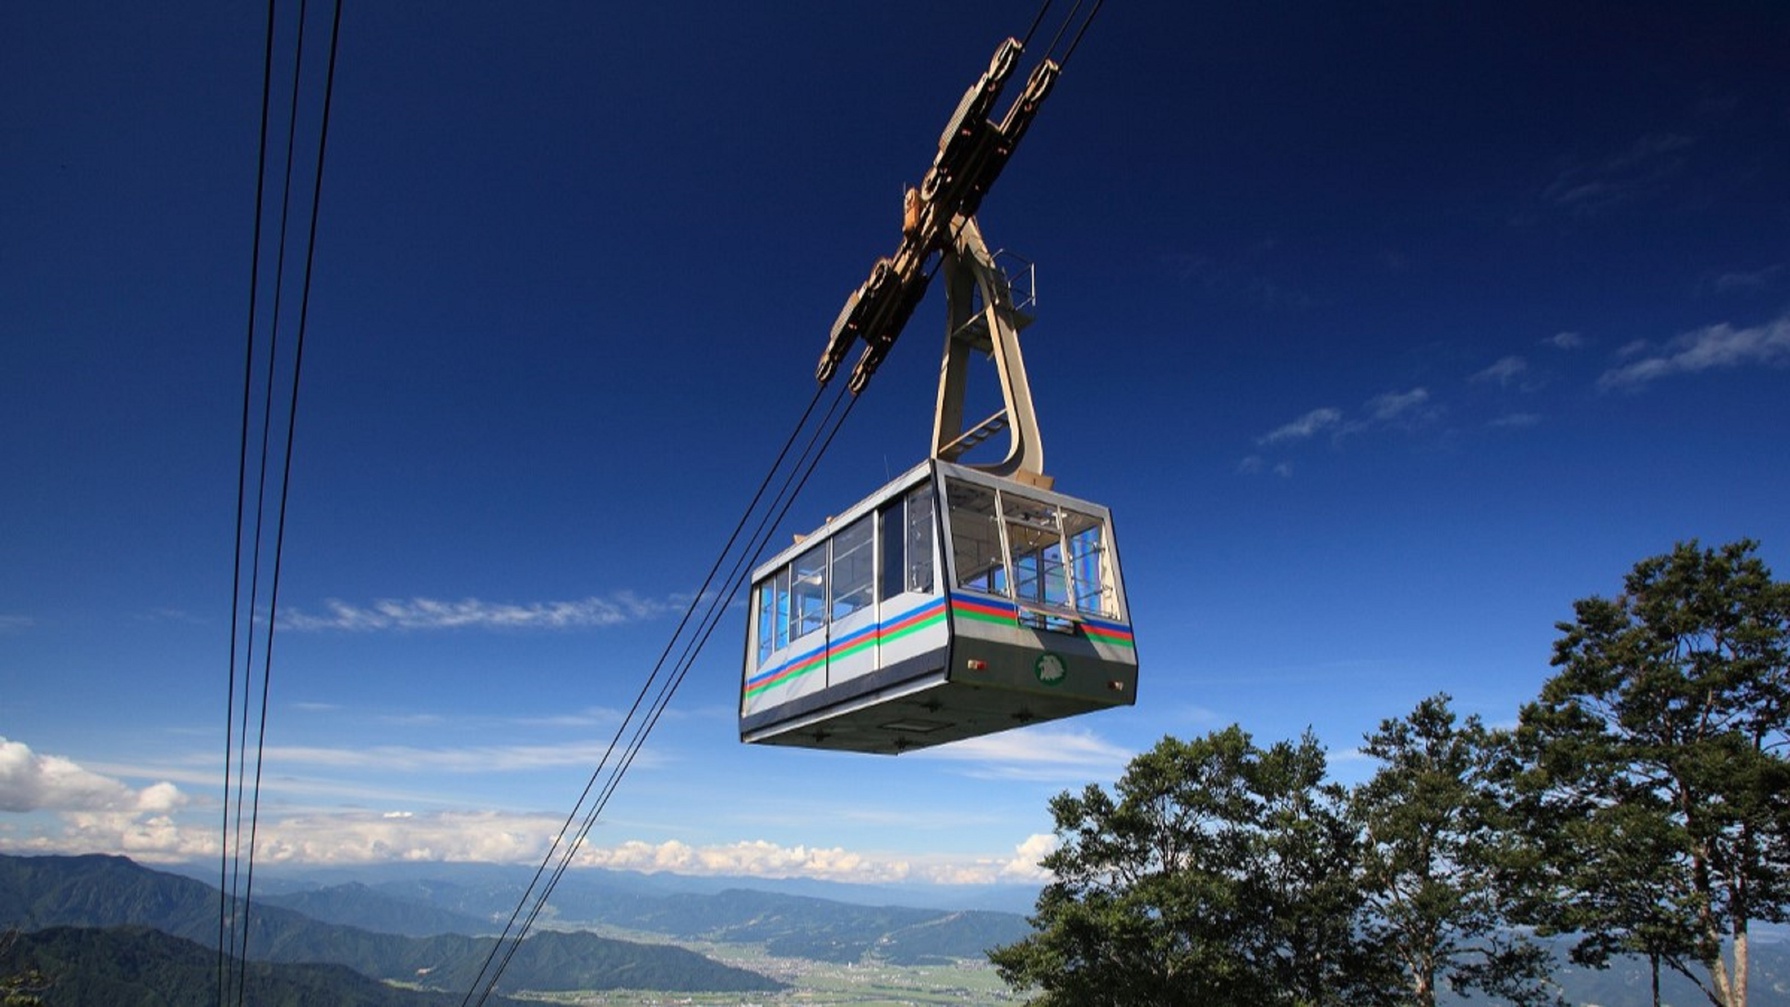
{"left": 13, "top": 857, "right": 1790, "bottom": 1007}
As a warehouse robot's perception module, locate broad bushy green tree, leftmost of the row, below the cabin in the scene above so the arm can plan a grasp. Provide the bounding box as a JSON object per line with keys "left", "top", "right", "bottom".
{"left": 990, "top": 726, "right": 1382, "bottom": 1007}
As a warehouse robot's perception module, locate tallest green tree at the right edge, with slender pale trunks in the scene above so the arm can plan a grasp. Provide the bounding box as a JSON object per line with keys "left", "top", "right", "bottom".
{"left": 1516, "top": 540, "right": 1790, "bottom": 1007}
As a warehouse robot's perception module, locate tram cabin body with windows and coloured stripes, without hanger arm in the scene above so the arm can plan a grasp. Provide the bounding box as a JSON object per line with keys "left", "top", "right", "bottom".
{"left": 739, "top": 460, "right": 1137, "bottom": 753}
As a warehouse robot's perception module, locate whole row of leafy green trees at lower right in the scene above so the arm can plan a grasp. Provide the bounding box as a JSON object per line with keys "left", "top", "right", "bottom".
{"left": 990, "top": 540, "right": 1790, "bottom": 1007}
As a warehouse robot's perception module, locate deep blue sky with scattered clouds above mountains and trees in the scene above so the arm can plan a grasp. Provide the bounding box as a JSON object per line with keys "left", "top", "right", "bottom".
{"left": 0, "top": 0, "right": 1790, "bottom": 884}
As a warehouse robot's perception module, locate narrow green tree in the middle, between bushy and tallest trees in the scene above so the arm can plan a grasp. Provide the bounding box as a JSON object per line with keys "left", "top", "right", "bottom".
{"left": 1351, "top": 696, "right": 1557, "bottom": 1007}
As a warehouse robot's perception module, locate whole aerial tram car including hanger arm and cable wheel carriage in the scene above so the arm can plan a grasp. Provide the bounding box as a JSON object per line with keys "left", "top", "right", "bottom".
{"left": 739, "top": 27, "right": 1137, "bottom": 753}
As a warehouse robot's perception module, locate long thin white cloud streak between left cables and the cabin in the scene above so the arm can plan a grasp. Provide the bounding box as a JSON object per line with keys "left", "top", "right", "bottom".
{"left": 281, "top": 592, "right": 675, "bottom": 633}
